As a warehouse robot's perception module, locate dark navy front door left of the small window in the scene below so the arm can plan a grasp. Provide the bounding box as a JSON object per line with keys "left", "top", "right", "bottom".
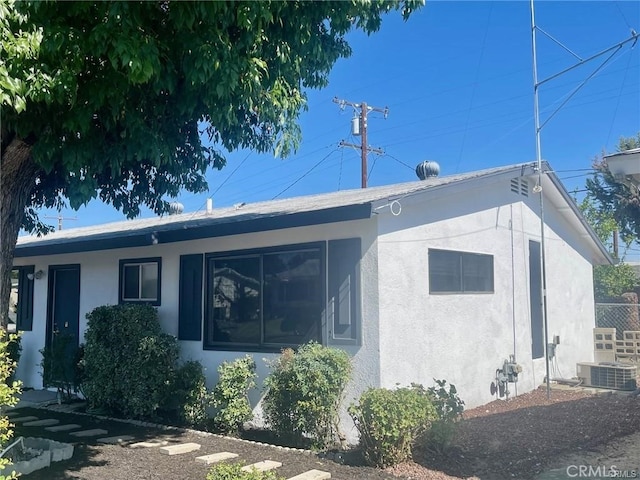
{"left": 44, "top": 265, "right": 80, "bottom": 386}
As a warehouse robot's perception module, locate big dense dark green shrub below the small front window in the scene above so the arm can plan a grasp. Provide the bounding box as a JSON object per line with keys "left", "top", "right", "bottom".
{"left": 82, "top": 305, "right": 179, "bottom": 418}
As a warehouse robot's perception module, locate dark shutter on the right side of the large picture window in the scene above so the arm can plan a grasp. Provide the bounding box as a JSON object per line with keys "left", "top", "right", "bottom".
{"left": 327, "top": 238, "right": 362, "bottom": 345}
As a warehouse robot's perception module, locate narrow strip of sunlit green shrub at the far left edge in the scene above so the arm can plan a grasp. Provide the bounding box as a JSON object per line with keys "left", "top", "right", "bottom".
{"left": 0, "top": 330, "right": 21, "bottom": 480}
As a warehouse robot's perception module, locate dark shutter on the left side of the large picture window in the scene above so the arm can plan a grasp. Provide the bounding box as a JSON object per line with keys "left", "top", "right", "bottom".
{"left": 178, "top": 254, "right": 204, "bottom": 340}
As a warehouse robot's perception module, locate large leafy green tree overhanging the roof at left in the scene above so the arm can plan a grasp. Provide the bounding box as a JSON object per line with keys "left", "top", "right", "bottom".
{"left": 0, "top": 0, "right": 422, "bottom": 328}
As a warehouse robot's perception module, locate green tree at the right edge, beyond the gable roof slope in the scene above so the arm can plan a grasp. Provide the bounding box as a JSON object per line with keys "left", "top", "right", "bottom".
{"left": 580, "top": 133, "right": 640, "bottom": 301}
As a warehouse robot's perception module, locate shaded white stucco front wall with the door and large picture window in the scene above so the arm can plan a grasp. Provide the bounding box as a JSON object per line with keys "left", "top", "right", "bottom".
{"left": 14, "top": 220, "right": 380, "bottom": 429}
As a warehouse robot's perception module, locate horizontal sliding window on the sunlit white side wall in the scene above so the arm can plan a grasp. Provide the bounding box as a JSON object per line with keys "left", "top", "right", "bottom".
{"left": 429, "top": 248, "right": 494, "bottom": 293}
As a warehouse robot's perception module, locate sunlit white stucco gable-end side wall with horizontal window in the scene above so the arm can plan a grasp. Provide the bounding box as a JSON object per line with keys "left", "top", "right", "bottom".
{"left": 378, "top": 181, "right": 594, "bottom": 408}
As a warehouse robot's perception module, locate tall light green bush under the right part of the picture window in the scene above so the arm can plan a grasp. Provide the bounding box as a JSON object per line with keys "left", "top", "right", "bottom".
{"left": 263, "top": 342, "right": 351, "bottom": 448}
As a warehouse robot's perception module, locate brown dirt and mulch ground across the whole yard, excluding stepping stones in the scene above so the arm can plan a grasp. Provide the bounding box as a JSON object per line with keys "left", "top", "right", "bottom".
{"left": 7, "top": 390, "right": 640, "bottom": 480}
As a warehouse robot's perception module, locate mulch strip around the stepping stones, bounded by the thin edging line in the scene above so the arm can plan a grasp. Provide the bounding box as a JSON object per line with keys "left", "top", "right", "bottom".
{"left": 15, "top": 408, "right": 396, "bottom": 480}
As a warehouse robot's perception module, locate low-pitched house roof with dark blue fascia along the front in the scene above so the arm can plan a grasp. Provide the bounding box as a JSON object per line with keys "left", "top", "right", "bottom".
{"left": 15, "top": 163, "right": 611, "bottom": 261}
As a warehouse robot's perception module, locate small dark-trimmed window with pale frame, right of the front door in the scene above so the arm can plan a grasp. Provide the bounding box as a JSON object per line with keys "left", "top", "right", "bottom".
{"left": 119, "top": 258, "right": 162, "bottom": 306}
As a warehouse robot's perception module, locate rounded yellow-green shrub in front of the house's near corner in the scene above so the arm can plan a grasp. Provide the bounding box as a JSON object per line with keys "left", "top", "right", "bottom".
{"left": 349, "top": 385, "right": 437, "bottom": 467}
